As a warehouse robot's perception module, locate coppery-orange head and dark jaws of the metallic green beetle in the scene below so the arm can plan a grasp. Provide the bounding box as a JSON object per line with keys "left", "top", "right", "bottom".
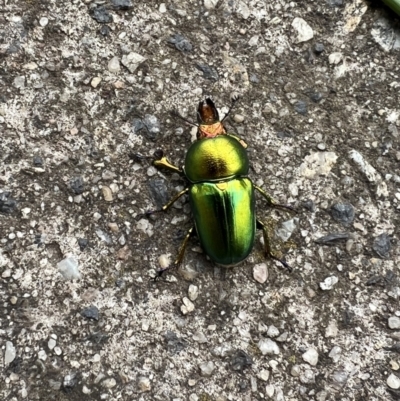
{"left": 197, "top": 98, "right": 226, "bottom": 139}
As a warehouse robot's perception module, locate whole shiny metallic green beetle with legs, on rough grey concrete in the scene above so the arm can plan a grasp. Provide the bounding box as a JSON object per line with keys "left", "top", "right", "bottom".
{"left": 147, "top": 98, "right": 293, "bottom": 277}
